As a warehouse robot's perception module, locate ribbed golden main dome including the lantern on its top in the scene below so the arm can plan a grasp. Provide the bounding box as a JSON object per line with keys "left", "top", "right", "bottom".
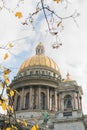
{"left": 19, "top": 43, "right": 60, "bottom": 74}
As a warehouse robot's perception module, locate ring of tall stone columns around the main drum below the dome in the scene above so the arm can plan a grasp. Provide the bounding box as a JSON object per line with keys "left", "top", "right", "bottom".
{"left": 14, "top": 86, "right": 57, "bottom": 111}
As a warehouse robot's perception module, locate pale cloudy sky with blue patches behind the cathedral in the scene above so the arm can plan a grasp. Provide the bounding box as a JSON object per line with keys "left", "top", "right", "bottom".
{"left": 0, "top": 0, "right": 87, "bottom": 114}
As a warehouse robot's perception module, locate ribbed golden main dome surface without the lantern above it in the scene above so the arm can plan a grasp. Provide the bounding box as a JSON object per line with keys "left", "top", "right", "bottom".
{"left": 19, "top": 55, "right": 60, "bottom": 73}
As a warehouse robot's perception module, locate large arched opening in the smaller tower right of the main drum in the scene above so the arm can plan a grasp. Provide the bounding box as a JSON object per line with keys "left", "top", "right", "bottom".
{"left": 64, "top": 95, "right": 72, "bottom": 109}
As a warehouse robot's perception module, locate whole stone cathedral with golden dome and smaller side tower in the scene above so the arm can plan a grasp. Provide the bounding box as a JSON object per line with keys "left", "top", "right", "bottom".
{"left": 10, "top": 43, "right": 87, "bottom": 130}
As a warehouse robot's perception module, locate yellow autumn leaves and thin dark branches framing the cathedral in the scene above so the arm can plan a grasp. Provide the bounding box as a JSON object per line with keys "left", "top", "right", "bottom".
{"left": 0, "top": 0, "right": 79, "bottom": 130}
